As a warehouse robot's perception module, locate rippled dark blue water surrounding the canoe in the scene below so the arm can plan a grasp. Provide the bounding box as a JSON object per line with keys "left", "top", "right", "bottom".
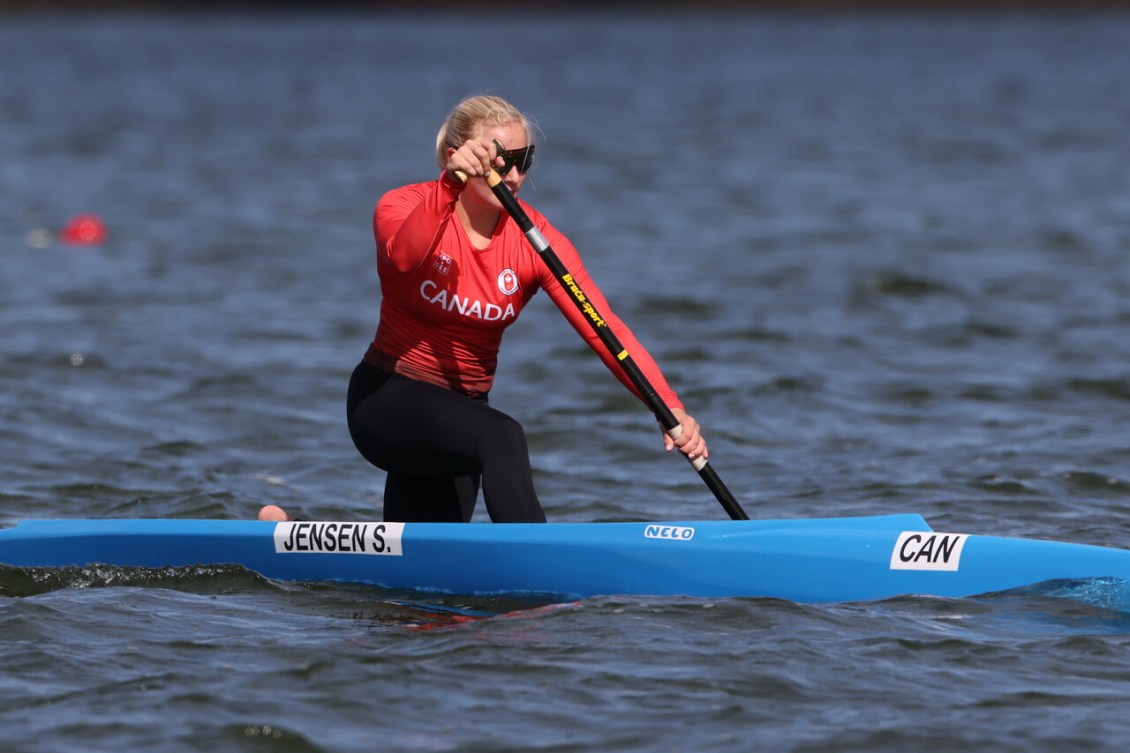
{"left": 0, "top": 11, "right": 1130, "bottom": 753}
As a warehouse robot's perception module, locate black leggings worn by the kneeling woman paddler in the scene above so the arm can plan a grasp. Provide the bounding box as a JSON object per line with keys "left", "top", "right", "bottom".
{"left": 347, "top": 362, "right": 546, "bottom": 522}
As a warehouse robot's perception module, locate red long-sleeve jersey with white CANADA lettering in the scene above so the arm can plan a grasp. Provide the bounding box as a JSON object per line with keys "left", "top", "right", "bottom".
{"left": 365, "top": 176, "right": 683, "bottom": 409}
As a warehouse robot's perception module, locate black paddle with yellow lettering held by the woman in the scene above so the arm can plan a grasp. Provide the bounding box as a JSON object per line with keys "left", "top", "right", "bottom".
{"left": 458, "top": 150, "right": 749, "bottom": 520}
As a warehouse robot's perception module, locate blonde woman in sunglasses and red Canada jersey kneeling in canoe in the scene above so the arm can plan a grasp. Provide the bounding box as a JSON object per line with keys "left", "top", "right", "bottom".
{"left": 260, "top": 96, "right": 707, "bottom": 522}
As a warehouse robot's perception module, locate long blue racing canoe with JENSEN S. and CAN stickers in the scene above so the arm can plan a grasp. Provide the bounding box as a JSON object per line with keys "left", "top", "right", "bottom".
{"left": 0, "top": 506, "right": 1130, "bottom": 603}
